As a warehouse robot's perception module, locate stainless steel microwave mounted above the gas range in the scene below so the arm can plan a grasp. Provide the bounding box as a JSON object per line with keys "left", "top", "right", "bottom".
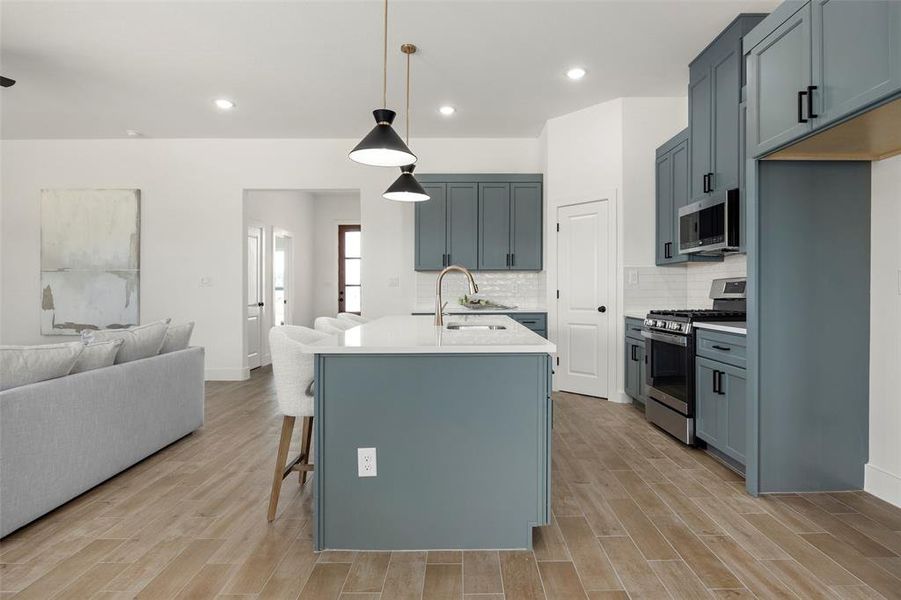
{"left": 679, "top": 188, "right": 741, "bottom": 254}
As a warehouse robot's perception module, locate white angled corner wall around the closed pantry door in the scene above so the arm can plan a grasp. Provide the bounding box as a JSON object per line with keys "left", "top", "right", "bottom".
{"left": 539, "top": 98, "right": 688, "bottom": 402}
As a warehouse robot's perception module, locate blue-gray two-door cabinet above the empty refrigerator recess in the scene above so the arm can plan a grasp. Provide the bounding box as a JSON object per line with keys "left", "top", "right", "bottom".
{"left": 745, "top": 0, "right": 901, "bottom": 158}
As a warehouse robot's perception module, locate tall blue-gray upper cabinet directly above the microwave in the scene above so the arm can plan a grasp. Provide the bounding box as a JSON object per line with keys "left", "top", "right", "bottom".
{"left": 688, "top": 14, "right": 763, "bottom": 202}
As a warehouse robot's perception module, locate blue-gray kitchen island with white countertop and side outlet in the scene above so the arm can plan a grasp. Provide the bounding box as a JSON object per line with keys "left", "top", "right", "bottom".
{"left": 314, "top": 315, "right": 556, "bottom": 550}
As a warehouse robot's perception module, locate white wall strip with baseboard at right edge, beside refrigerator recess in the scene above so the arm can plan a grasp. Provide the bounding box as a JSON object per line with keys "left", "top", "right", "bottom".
{"left": 865, "top": 156, "right": 901, "bottom": 506}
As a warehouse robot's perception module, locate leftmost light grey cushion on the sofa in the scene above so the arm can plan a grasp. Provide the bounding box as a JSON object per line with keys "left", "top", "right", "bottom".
{"left": 0, "top": 342, "right": 84, "bottom": 390}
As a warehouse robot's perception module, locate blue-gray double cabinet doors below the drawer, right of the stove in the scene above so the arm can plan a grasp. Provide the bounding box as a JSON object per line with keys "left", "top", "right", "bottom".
{"left": 695, "top": 357, "right": 747, "bottom": 465}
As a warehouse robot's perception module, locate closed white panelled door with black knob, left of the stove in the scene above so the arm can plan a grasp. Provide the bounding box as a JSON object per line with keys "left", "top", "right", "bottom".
{"left": 556, "top": 201, "right": 610, "bottom": 398}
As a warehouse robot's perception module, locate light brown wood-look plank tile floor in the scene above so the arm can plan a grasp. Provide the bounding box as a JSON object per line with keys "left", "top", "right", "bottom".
{"left": 0, "top": 369, "right": 901, "bottom": 600}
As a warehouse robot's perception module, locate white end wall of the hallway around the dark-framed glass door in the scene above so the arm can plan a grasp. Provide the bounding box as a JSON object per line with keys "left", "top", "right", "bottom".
{"left": 312, "top": 192, "right": 360, "bottom": 318}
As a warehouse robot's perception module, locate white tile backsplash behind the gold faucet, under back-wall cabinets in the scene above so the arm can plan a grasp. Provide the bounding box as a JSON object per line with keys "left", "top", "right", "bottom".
{"left": 416, "top": 271, "right": 547, "bottom": 310}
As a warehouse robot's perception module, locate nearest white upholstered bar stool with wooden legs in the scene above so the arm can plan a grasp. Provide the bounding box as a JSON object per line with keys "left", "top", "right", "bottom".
{"left": 268, "top": 325, "right": 329, "bottom": 521}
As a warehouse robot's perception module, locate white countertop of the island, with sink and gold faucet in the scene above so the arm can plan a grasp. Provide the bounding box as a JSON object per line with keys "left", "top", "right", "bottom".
{"left": 311, "top": 314, "right": 557, "bottom": 354}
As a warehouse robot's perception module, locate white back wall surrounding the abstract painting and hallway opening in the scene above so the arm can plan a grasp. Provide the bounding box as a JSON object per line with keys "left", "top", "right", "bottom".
{"left": 0, "top": 139, "right": 541, "bottom": 379}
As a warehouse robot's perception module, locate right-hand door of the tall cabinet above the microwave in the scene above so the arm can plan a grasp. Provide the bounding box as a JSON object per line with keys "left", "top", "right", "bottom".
{"left": 710, "top": 38, "right": 742, "bottom": 192}
